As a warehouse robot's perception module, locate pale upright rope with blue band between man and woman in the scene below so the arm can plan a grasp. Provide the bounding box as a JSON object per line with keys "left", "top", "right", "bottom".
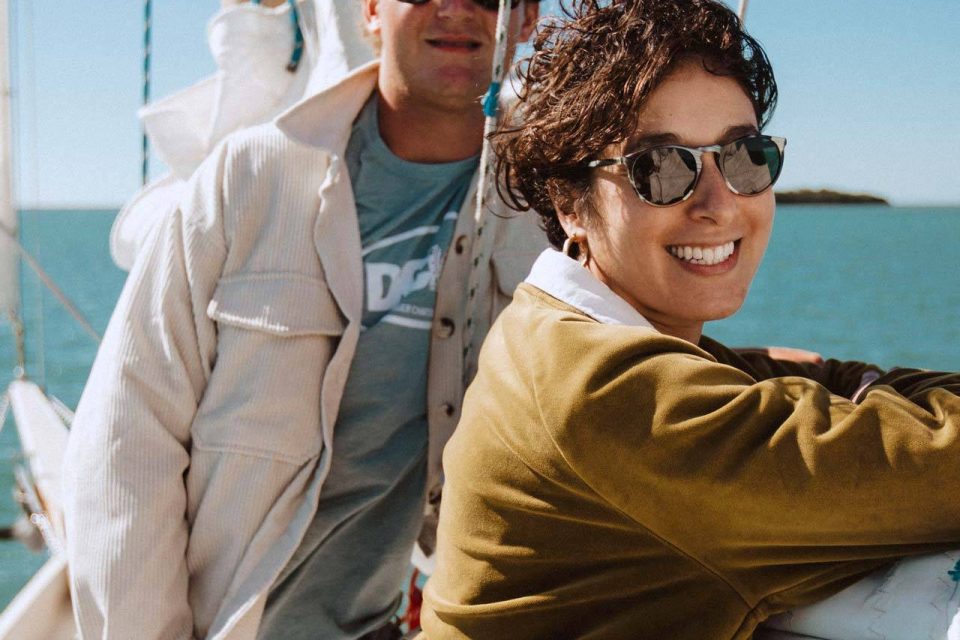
{"left": 463, "top": 0, "right": 511, "bottom": 368}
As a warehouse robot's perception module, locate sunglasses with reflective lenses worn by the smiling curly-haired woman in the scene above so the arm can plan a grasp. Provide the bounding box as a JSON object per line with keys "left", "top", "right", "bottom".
{"left": 587, "top": 134, "right": 787, "bottom": 207}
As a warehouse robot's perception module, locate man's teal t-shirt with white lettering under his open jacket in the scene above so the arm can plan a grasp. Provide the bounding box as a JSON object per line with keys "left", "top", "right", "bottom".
{"left": 259, "top": 93, "right": 478, "bottom": 640}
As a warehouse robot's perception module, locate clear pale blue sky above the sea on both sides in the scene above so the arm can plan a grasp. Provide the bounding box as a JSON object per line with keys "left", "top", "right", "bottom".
{"left": 10, "top": 0, "right": 960, "bottom": 207}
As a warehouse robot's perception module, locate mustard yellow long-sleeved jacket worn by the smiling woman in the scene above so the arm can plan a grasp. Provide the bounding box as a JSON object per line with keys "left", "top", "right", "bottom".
{"left": 423, "top": 251, "right": 960, "bottom": 640}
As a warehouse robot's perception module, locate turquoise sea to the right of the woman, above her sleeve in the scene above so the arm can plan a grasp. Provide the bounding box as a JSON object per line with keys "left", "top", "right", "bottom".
{"left": 705, "top": 205, "right": 960, "bottom": 371}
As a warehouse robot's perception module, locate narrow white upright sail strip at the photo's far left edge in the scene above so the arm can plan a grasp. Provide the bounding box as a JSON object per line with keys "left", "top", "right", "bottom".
{"left": 0, "top": 0, "right": 20, "bottom": 320}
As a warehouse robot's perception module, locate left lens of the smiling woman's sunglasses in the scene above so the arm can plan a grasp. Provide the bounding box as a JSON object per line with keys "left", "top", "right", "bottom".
{"left": 630, "top": 147, "right": 697, "bottom": 206}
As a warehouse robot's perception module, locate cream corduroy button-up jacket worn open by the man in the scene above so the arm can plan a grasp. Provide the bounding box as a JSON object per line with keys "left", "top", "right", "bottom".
{"left": 65, "top": 63, "right": 545, "bottom": 640}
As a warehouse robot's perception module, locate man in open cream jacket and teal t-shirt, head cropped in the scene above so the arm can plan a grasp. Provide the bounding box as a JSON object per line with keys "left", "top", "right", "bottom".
{"left": 66, "top": 0, "right": 542, "bottom": 639}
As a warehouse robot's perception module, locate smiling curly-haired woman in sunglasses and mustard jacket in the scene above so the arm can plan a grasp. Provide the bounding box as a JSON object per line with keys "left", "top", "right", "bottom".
{"left": 424, "top": 0, "right": 960, "bottom": 640}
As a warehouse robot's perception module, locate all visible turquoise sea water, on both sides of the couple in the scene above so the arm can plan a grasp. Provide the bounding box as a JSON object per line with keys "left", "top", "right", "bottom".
{"left": 0, "top": 205, "right": 960, "bottom": 608}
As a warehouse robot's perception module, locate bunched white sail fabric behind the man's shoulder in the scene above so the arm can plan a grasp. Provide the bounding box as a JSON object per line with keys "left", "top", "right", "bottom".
{"left": 110, "top": 0, "right": 374, "bottom": 269}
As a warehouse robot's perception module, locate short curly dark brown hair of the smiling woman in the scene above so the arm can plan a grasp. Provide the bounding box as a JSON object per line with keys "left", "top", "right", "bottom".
{"left": 493, "top": 0, "right": 777, "bottom": 247}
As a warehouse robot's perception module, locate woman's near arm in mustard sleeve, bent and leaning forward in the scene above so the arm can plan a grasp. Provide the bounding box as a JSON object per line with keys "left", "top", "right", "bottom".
{"left": 537, "top": 323, "right": 960, "bottom": 608}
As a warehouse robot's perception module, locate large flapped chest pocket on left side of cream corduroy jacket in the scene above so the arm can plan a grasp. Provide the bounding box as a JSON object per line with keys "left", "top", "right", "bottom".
{"left": 193, "top": 273, "right": 345, "bottom": 464}
